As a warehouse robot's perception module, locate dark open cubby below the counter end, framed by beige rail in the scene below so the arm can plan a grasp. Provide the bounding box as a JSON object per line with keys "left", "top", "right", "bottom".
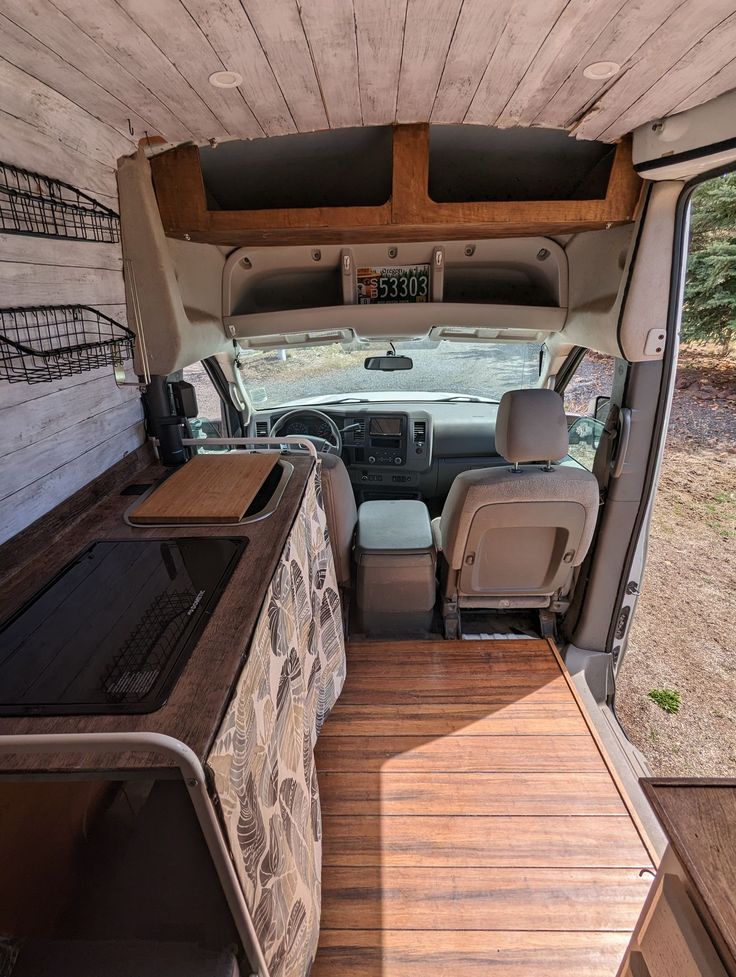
{"left": 0, "top": 769, "right": 242, "bottom": 977}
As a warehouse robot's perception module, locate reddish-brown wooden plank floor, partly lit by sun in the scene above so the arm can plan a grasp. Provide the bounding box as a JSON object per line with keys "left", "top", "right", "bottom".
{"left": 312, "top": 641, "right": 651, "bottom": 977}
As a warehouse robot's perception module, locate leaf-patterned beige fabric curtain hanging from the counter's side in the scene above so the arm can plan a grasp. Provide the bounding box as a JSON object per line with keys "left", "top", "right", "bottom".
{"left": 208, "top": 466, "right": 345, "bottom": 977}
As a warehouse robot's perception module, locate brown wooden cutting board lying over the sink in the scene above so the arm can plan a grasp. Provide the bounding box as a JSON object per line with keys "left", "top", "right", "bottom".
{"left": 129, "top": 451, "right": 280, "bottom": 526}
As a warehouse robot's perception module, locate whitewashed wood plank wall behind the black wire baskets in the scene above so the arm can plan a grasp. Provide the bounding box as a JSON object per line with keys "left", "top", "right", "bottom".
{"left": 0, "top": 90, "right": 144, "bottom": 543}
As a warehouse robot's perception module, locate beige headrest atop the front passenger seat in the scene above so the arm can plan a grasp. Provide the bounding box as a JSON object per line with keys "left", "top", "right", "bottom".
{"left": 496, "top": 389, "right": 569, "bottom": 463}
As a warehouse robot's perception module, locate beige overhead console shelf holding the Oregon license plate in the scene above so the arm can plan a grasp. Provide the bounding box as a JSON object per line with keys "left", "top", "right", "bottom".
{"left": 222, "top": 237, "right": 568, "bottom": 349}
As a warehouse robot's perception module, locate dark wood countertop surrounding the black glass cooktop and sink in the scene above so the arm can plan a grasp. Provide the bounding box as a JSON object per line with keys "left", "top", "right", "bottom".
{"left": 0, "top": 450, "right": 313, "bottom": 773}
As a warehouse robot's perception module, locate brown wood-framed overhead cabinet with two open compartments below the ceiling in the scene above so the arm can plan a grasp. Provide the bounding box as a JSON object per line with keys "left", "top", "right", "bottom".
{"left": 151, "top": 124, "right": 641, "bottom": 246}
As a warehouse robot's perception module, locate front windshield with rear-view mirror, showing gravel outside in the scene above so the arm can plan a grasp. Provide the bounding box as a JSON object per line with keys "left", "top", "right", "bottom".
{"left": 241, "top": 339, "right": 541, "bottom": 409}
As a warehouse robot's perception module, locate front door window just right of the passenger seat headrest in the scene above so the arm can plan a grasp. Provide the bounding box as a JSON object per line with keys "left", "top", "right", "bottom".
{"left": 564, "top": 350, "right": 616, "bottom": 471}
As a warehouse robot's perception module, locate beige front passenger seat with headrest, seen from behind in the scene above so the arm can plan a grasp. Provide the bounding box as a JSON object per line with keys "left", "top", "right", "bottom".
{"left": 433, "top": 389, "right": 599, "bottom": 637}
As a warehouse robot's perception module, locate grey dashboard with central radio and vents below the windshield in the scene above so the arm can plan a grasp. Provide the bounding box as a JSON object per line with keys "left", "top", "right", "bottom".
{"left": 249, "top": 401, "right": 506, "bottom": 501}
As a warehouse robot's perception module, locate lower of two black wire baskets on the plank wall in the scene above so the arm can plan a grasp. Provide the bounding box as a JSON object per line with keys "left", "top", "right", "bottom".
{"left": 0, "top": 305, "right": 135, "bottom": 383}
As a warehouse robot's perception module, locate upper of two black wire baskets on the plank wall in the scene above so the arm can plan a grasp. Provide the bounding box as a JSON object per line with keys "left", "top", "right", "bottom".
{"left": 0, "top": 163, "right": 120, "bottom": 244}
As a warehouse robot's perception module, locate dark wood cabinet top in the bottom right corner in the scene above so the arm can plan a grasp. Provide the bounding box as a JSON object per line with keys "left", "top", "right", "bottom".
{"left": 641, "top": 778, "right": 736, "bottom": 968}
